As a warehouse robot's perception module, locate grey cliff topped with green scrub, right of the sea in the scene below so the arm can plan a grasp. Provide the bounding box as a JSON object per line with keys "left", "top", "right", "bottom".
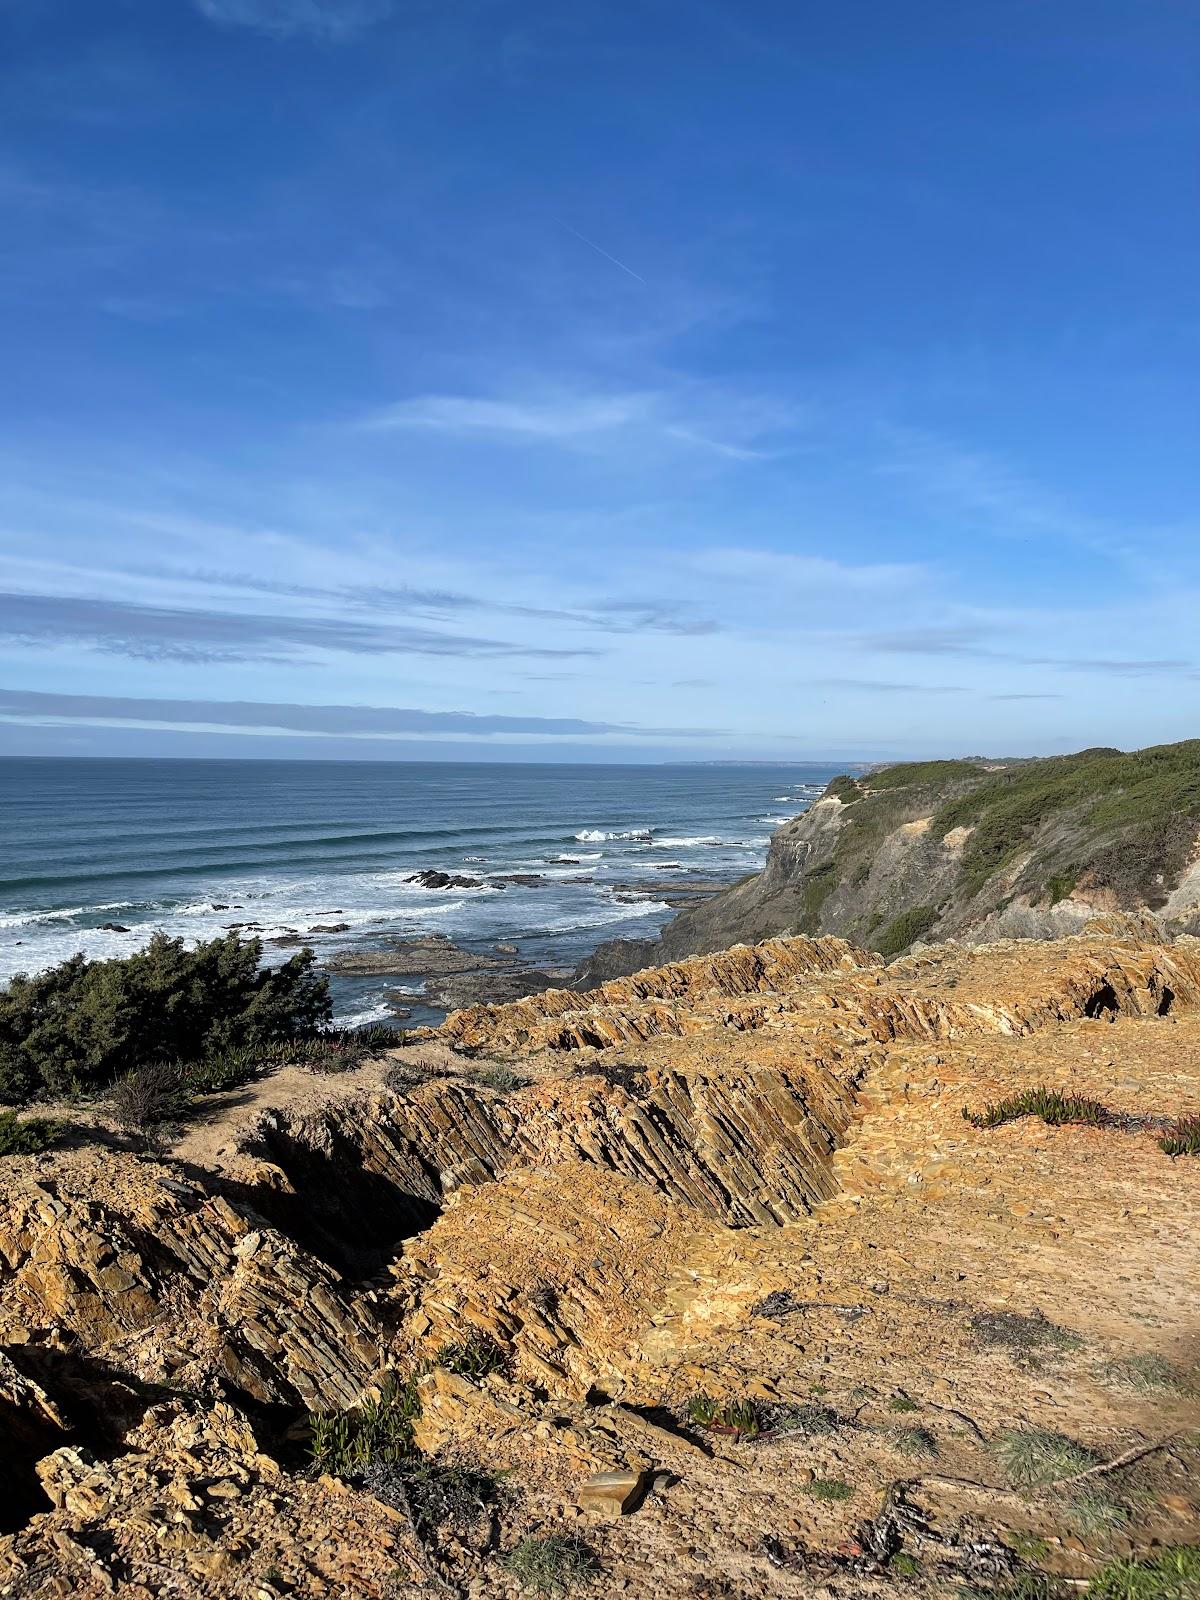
{"left": 624, "top": 741, "right": 1200, "bottom": 974}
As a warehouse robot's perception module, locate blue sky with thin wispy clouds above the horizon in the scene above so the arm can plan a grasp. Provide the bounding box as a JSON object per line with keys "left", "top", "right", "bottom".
{"left": 0, "top": 0, "right": 1200, "bottom": 760}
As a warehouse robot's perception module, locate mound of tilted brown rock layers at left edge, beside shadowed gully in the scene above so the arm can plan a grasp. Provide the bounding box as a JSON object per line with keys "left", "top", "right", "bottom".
{"left": 0, "top": 1157, "right": 381, "bottom": 1405}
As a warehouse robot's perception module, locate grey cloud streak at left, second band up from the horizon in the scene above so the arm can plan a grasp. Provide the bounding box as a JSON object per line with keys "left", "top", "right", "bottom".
{"left": 0, "top": 594, "right": 600, "bottom": 662}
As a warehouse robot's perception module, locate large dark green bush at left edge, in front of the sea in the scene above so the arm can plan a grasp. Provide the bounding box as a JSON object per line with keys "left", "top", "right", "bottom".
{"left": 0, "top": 933, "right": 331, "bottom": 1102}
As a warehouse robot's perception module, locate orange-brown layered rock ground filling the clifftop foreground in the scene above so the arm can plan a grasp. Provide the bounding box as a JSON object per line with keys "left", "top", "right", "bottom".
{"left": 0, "top": 931, "right": 1200, "bottom": 1600}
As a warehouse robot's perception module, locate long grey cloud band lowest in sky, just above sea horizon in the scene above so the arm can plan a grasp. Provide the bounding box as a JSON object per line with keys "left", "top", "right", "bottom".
{"left": 0, "top": 690, "right": 713, "bottom": 739}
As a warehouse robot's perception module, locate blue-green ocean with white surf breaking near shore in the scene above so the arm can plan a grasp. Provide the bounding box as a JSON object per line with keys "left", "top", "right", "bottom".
{"left": 0, "top": 758, "right": 842, "bottom": 1027}
